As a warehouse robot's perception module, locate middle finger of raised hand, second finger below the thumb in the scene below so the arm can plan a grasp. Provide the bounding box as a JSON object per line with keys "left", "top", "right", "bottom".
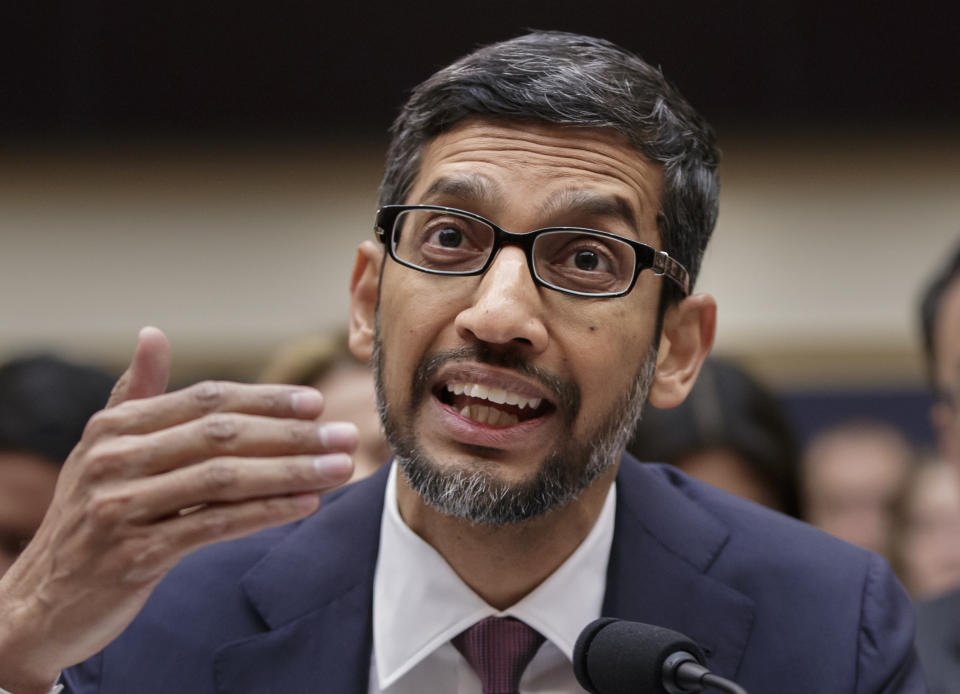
{"left": 84, "top": 413, "right": 359, "bottom": 481}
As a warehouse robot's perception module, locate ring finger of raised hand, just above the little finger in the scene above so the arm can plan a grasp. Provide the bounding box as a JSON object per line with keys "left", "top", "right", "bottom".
{"left": 120, "top": 453, "right": 353, "bottom": 523}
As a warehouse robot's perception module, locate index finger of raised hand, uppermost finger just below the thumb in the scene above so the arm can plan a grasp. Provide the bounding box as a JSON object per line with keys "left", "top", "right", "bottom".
{"left": 92, "top": 381, "right": 323, "bottom": 436}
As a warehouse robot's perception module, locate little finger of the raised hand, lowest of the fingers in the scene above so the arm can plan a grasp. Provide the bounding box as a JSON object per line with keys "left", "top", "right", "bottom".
{"left": 125, "top": 493, "right": 320, "bottom": 582}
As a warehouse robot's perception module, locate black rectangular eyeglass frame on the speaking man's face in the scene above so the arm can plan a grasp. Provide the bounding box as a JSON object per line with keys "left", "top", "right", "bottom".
{"left": 374, "top": 205, "right": 690, "bottom": 299}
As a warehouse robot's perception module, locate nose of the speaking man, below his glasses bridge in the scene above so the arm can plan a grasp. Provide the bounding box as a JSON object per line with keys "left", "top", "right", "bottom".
{"left": 455, "top": 246, "right": 548, "bottom": 353}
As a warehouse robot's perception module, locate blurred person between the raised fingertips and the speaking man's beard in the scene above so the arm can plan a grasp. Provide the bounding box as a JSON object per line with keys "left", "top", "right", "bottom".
{"left": 259, "top": 331, "right": 393, "bottom": 482}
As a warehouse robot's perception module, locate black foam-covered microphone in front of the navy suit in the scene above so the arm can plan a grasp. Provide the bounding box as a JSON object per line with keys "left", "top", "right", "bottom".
{"left": 573, "top": 617, "right": 747, "bottom": 694}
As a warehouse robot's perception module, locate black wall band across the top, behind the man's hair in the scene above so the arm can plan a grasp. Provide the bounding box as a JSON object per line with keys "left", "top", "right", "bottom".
{"left": 0, "top": 0, "right": 960, "bottom": 140}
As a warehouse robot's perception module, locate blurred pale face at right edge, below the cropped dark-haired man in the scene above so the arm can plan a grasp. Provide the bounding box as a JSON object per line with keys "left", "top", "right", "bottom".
{"left": 890, "top": 456, "right": 960, "bottom": 599}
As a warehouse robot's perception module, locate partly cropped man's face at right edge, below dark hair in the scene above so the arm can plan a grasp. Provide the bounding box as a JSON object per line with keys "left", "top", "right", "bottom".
{"left": 933, "top": 279, "right": 960, "bottom": 465}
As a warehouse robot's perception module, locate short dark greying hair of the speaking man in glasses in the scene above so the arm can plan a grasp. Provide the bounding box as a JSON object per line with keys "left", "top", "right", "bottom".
{"left": 380, "top": 32, "right": 720, "bottom": 302}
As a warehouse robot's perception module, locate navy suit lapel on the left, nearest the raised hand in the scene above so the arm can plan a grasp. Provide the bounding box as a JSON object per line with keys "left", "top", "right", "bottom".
{"left": 214, "top": 465, "right": 389, "bottom": 694}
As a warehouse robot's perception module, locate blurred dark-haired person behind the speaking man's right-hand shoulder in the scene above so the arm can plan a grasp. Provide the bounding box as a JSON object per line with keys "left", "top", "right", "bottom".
{"left": 627, "top": 358, "right": 800, "bottom": 518}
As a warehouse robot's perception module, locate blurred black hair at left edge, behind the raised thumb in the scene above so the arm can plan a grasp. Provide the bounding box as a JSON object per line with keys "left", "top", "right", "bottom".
{"left": 0, "top": 356, "right": 113, "bottom": 465}
